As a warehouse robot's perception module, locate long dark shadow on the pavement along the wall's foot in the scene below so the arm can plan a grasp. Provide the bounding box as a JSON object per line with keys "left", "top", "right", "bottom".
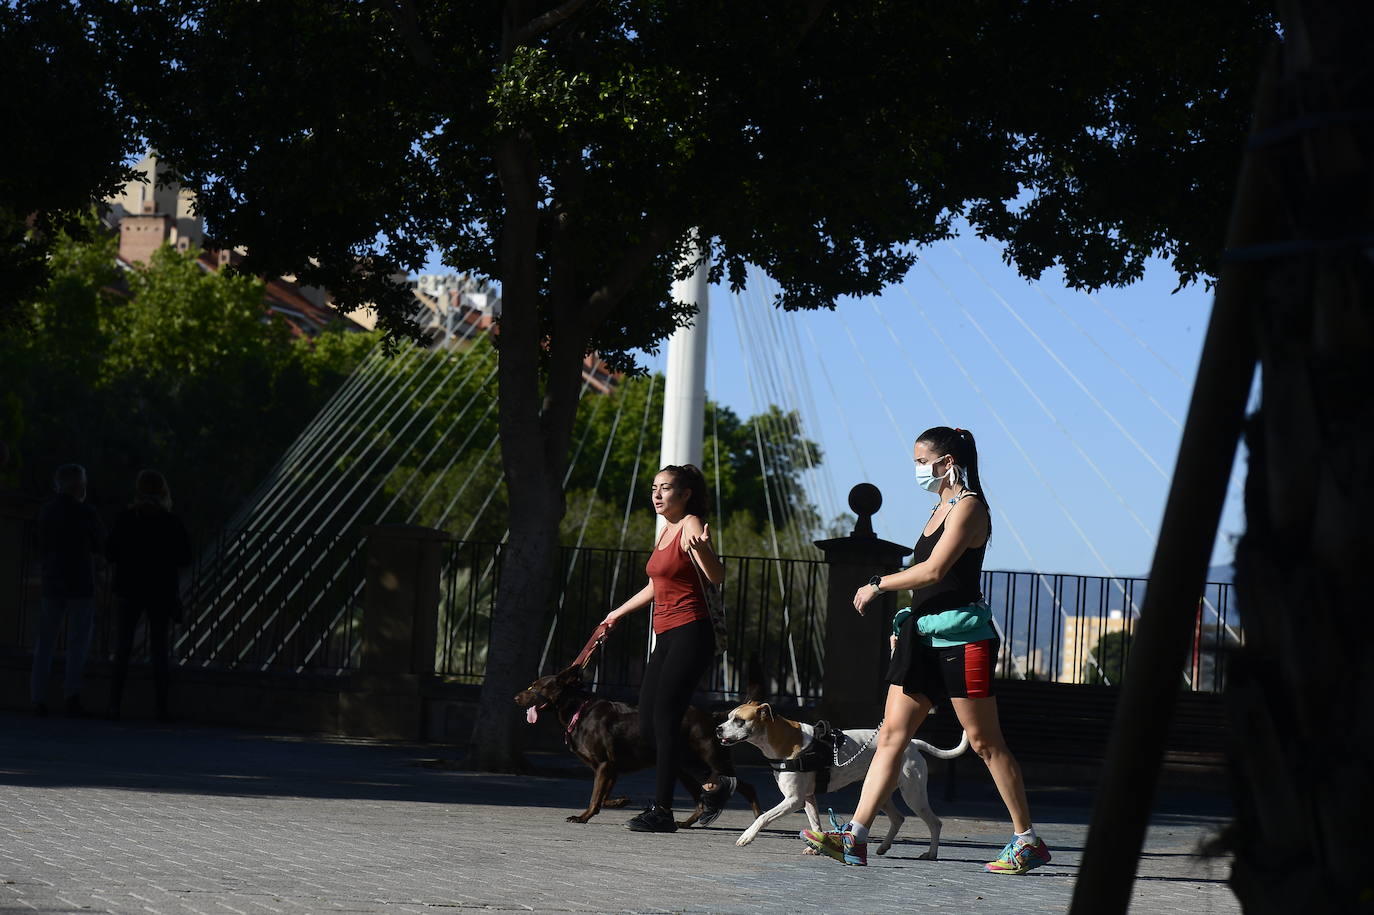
{"left": 0, "top": 712, "right": 1230, "bottom": 829}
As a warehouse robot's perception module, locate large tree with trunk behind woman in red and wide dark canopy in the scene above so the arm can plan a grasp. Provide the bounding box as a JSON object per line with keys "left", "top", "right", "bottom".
{"left": 106, "top": 0, "right": 1272, "bottom": 768}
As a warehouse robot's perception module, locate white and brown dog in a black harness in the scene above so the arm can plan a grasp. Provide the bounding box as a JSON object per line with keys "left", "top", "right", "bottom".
{"left": 716, "top": 702, "right": 969, "bottom": 860}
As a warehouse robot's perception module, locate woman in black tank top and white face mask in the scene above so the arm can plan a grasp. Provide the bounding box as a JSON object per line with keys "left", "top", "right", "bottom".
{"left": 802, "top": 426, "right": 1050, "bottom": 874}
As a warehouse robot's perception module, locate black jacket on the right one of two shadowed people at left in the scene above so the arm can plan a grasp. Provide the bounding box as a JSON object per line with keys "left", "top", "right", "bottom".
{"left": 104, "top": 504, "right": 191, "bottom": 615}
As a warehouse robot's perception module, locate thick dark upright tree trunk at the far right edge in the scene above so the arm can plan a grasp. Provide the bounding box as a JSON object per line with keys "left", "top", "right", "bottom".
{"left": 1227, "top": 0, "right": 1374, "bottom": 912}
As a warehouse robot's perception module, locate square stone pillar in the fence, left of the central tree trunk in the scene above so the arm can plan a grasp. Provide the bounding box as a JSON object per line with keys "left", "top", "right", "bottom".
{"left": 361, "top": 525, "right": 448, "bottom": 675}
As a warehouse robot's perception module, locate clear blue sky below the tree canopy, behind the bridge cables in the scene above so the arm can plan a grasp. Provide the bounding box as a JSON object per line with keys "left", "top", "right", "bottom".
{"left": 637, "top": 234, "right": 1243, "bottom": 576}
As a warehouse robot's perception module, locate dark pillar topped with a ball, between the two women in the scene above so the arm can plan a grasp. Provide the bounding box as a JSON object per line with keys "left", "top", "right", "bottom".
{"left": 816, "top": 484, "right": 911, "bottom": 727}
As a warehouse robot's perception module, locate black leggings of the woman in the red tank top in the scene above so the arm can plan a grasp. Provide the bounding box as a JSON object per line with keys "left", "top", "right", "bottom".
{"left": 639, "top": 620, "right": 716, "bottom": 808}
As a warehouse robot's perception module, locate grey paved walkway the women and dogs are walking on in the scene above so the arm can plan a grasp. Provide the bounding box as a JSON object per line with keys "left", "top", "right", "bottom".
{"left": 0, "top": 713, "right": 1239, "bottom": 915}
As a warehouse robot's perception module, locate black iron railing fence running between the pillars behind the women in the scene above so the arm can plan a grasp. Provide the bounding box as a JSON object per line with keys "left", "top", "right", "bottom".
{"left": 8, "top": 519, "right": 1243, "bottom": 692}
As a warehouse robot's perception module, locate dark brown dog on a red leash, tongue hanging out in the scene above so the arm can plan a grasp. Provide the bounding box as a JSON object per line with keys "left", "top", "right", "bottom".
{"left": 515, "top": 666, "right": 763, "bottom": 827}
